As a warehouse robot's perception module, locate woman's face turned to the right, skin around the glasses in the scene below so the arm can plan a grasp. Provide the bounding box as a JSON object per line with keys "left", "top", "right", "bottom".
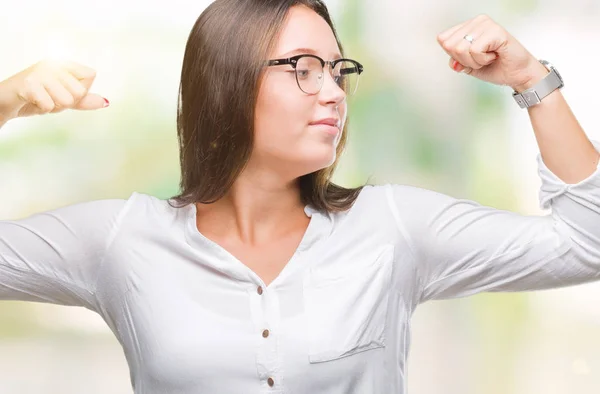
{"left": 251, "top": 6, "right": 347, "bottom": 178}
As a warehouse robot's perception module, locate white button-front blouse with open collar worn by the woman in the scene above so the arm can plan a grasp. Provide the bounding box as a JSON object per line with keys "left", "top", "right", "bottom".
{"left": 0, "top": 142, "right": 600, "bottom": 394}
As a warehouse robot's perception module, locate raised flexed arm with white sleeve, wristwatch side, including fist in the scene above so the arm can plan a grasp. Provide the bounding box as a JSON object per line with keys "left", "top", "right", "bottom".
{"left": 388, "top": 15, "right": 600, "bottom": 302}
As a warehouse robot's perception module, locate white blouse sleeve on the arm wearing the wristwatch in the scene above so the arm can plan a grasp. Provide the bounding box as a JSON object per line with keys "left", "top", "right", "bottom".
{"left": 388, "top": 142, "right": 600, "bottom": 302}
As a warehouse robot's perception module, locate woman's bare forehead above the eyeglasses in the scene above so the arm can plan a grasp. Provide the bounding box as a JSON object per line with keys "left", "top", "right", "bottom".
{"left": 272, "top": 6, "right": 341, "bottom": 59}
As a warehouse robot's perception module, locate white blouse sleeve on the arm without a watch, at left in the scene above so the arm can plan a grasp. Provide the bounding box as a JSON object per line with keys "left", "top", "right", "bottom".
{"left": 0, "top": 199, "right": 127, "bottom": 310}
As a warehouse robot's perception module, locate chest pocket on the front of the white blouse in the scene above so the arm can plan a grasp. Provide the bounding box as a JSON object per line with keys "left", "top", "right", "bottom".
{"left": 303, "top": 244, "right": 394, "bottom": 363}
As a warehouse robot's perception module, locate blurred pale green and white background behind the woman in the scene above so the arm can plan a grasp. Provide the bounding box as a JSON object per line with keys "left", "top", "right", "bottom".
{"left": 0, "top": 0, "right": 600, "bottom": 394}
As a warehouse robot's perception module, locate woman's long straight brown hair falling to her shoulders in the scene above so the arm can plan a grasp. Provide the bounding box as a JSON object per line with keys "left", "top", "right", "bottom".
{"left": 171, "top": 0, "right": 364, "bottom": 212}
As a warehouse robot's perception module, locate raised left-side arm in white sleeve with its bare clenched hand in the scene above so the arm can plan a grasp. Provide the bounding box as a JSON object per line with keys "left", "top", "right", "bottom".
{"left": 0, "top": 61, "right": 119, "bottom": 309}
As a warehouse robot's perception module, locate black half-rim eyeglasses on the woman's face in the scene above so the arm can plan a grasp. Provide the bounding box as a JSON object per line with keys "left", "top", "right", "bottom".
{"left": 267, "top": 54, "right": 363, "bottom": 96}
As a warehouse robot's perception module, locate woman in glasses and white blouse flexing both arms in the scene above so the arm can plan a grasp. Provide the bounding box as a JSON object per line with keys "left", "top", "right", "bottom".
{"left": 0, "top": 0, "right": 600, "bottom": 394}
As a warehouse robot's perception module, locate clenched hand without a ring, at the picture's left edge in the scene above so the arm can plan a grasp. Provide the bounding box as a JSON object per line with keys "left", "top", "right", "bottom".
{"left": 0, "top": 60, "right": 109, "bottom": 121}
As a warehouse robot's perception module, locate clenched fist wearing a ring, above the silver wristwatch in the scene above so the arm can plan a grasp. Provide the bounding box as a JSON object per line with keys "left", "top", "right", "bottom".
{"left": 437, "top": 15, "right": 548, "bottom": 92}
